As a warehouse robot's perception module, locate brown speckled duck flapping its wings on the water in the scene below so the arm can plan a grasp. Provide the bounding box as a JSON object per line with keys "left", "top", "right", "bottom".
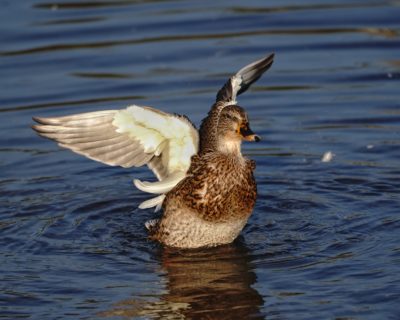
{"left": 32, "top": 54, "right": 274, "bottom": 249}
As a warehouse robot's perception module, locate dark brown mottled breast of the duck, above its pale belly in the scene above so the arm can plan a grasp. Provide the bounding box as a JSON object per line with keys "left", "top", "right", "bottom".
{"left": 164, "top": 152, "right": 257, "bottom": 222}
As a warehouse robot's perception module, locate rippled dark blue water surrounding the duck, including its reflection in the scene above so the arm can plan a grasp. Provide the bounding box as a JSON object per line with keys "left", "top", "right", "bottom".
{"left": 0, "top": 0, "right": 400, "bottom": 319}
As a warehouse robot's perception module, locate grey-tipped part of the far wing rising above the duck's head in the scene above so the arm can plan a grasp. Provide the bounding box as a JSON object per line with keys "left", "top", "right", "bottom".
{"left": 216, "top": 54, "right": 274, "bottom": 104}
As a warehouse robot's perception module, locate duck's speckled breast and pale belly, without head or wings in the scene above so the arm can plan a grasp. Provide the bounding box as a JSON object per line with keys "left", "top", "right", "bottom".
{"left": 149, "top": 152, "right": 257, "bottom": 248}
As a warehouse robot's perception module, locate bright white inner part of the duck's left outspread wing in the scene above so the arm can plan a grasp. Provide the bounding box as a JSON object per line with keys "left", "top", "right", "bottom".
{"left": 113, "top": 106, "right": 199, "bottom": 209}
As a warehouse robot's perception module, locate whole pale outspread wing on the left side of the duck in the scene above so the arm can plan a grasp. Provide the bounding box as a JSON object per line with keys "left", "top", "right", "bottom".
{"left": 32, "top": 105, "right": 199, "bottom": 208}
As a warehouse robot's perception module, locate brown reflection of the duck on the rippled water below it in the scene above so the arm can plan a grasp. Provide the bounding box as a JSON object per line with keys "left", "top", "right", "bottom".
{"left": 103, "top": 241, "right": 264, "bottom": 319}
